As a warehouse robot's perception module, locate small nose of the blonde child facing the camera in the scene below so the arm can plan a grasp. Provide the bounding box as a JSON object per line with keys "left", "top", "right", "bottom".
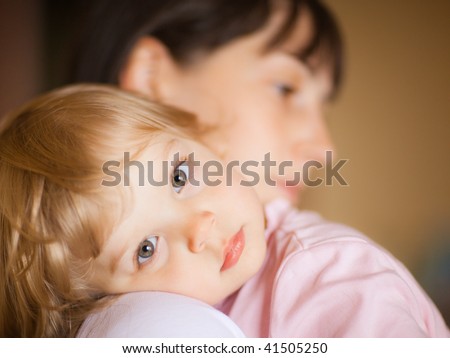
{"left": 187, "top": 211, "right": 216, "bottom": 253}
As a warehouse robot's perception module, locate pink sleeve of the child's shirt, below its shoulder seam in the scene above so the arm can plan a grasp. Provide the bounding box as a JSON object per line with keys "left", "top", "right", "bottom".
{"left": 270, "top": 239, "right": 450, "bottom": 337}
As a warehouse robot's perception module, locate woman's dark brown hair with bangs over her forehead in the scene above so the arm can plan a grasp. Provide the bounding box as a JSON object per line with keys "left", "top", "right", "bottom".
{"left": 69, "top": 0, "right": 342, "bottom": 93}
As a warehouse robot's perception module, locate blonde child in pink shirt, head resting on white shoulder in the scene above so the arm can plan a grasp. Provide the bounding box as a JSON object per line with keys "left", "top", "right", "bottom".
{"left": 0, "top": 85, "right": 449, "bottom": 337}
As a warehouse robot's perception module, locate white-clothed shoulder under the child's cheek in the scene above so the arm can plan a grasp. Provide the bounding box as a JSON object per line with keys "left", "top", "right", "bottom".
{"left": 77, "top": 292, "right": 244, "bottom": 338}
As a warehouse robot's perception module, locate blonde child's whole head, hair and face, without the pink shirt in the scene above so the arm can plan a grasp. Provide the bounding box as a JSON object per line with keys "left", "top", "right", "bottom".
{"left": 0, "top": 85, "right": 265, "bottom": 337}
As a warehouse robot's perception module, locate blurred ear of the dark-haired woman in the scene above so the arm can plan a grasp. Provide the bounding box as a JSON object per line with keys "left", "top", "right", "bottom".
{"left": 119, "top": 36, "right": 179, "bottom": 101}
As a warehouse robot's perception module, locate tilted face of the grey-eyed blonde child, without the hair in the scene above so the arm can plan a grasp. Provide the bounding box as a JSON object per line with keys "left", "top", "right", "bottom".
{"left": 94, "top": 134, "right": 265, "bottom": 304}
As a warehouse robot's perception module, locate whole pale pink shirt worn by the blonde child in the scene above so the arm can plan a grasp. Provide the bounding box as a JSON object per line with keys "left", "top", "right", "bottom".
{"left": 218, "top": 200, "right": 450, "bottom": 337}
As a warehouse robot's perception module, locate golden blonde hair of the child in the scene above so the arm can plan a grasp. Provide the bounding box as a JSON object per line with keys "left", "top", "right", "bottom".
{"left": 0, "top": 85, "right": 195, "bottom": 337}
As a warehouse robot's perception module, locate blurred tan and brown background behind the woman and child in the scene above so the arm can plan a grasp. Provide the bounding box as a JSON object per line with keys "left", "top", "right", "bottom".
{"left": 0, "top": 0, "right": 450, "bottom": 322}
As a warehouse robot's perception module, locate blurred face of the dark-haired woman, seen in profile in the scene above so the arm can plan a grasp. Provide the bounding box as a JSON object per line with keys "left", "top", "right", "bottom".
{"left": 155, "top": 7, "right": 332, "bottom": 203}
